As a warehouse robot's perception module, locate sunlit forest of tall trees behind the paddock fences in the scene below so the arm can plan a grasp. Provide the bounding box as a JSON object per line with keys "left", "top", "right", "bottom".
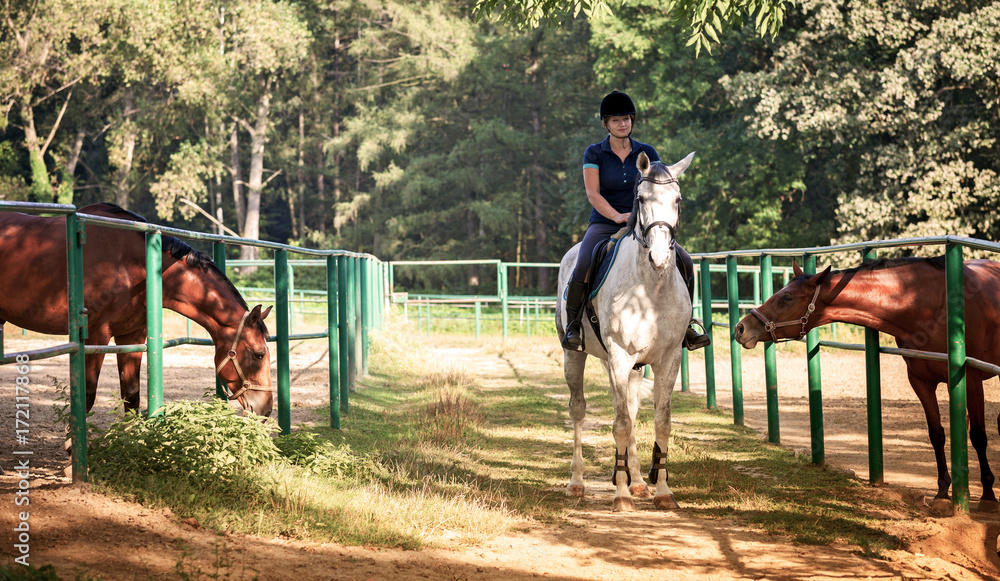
{"left": 0, "top": 0, "right": 1000, "bottom": 294}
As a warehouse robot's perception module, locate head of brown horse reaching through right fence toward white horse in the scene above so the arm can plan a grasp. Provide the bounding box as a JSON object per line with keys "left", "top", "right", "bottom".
{"left": 734, "top": 261, "right": 830, "bottom": 349}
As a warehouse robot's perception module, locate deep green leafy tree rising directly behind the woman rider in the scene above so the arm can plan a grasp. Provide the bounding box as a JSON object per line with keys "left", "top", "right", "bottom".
{"left": 590, "top": 0, "right": 820, "bottom": 252}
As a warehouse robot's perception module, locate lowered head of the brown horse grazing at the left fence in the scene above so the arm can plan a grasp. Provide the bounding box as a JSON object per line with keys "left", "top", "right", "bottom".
{"left": 215, "top": 305, "right": 274, "bottom": 417}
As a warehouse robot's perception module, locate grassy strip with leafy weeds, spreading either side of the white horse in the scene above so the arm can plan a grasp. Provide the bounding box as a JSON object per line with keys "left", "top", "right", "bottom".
{"left": 91, "top": 312, "right": 913, "bottom": 555}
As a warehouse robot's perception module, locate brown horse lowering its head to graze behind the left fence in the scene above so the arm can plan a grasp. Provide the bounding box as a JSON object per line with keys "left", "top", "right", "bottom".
{"left": 0, "top": 204, "right": 274, "bottom": 416}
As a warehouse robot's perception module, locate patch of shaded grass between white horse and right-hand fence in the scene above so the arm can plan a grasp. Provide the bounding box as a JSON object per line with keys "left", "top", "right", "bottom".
{"left": 639, "top": 392, "right": 919, "bottom": 556}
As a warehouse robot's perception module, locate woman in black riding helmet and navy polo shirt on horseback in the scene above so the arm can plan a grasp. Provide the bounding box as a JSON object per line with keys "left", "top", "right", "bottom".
{"left": 562, "top": 91, "right": 712, "bottom": 351}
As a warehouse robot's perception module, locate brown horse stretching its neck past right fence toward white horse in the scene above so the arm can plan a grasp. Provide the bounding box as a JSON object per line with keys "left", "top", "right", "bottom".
{"left": 735, "top": 257, "right": 1000, "bottom": 510}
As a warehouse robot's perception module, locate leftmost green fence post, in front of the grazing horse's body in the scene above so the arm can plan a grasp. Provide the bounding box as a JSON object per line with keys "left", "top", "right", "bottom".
{"left": 66, "top": 213, "right": 90, "bottom": 482}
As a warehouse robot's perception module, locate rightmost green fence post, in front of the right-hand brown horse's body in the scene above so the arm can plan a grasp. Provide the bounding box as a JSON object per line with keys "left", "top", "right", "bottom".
{"left": 945, "top": 243, "right": 969, "bottom": 515}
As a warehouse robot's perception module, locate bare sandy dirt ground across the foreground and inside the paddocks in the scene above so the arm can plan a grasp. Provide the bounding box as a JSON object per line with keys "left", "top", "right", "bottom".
{"left": 0, "top": 340, "right": 1000, "bottom": 581}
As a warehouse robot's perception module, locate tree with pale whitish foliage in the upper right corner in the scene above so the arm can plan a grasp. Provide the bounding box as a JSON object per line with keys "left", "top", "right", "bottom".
{"left": 732, "top": 0, "right": 1000, "bottom": 253}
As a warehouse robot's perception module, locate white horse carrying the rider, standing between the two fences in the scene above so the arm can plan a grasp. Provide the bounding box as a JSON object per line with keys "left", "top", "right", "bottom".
{"left": 556, "top": 152, "right": 694, "bottom": 511}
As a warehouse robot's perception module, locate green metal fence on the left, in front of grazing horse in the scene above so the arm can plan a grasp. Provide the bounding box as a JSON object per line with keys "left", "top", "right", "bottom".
{"left": 0, "top": 202, "right": 389, "bottom": 481}
